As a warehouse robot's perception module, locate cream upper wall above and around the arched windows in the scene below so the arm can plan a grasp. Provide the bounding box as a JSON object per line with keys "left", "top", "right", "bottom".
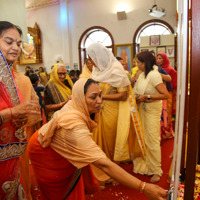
{"left": 24, "top": 0, "right": 176, "bottom": 71}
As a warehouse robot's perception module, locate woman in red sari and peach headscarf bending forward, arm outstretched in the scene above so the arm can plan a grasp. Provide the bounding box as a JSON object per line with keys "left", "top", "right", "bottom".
{"left": 28, "top": 78, "right": 167, "bottom": 200}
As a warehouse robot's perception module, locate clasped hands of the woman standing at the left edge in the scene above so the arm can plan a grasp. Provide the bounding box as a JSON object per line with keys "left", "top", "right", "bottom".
{"left": 11, "top": 100, "right": 41, "bottom": 119}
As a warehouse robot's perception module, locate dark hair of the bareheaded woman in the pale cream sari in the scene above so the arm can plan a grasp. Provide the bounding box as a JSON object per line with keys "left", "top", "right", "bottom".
{"left": 136, "top": 51, "right": 156, "bottom": 77}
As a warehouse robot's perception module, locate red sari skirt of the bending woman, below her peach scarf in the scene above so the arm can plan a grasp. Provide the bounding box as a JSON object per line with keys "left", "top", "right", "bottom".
{"left": 28, "top": 131, "right": 98, "bottom": 200}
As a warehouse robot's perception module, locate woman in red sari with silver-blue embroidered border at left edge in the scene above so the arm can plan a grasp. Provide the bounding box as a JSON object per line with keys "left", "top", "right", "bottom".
{"left": 0, "top": 21, "right": 41, "bottom": 199}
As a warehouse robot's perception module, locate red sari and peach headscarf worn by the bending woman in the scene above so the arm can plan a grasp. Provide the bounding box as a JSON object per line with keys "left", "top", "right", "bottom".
{"left": 28, "top": 78, "right": 106, "bottom": 200}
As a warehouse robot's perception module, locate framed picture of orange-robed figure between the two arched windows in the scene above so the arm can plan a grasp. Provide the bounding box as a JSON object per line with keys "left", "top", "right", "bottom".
{"left": 115, "top": 44, "right": 133, "bottom": 71}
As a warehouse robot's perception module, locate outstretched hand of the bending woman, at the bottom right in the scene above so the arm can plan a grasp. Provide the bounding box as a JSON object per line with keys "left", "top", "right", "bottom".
{"left": 143, "top": 183, "right": 168, "bottom": 200}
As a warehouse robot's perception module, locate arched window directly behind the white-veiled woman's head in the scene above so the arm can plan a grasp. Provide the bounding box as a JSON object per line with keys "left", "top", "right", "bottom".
{"left": 79, "top": 27, "right": 114, "bottom": 71}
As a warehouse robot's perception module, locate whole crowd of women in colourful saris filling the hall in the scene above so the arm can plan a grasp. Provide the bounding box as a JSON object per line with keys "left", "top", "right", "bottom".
{"left": 0, "top": 21, "right": 177, "bottom": 200}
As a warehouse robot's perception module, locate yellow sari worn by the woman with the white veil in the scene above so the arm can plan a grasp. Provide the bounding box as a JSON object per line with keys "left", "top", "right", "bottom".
{"left": 94, "top": 83, "right": 145, "bottom": 161}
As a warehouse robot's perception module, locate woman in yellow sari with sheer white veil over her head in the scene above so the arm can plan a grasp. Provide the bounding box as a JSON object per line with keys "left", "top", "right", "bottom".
{"left": 87, "top": 43, "right": 145, "bottom": 184}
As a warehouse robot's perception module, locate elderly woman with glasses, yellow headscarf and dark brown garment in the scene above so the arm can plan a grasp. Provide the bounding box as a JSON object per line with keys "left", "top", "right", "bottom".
{"left": 44, "top": 63, "right": 73, "bottom": 121}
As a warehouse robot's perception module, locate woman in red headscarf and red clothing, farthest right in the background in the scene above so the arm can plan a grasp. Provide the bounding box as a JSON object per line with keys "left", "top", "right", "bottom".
{"left": 156, "top": 53, "right": 177, "bottom": 139}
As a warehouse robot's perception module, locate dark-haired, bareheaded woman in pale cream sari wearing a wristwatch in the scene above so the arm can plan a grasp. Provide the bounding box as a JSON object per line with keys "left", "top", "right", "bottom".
{"left": 133, "top": 51, "right": 169, "bottom": 183}
